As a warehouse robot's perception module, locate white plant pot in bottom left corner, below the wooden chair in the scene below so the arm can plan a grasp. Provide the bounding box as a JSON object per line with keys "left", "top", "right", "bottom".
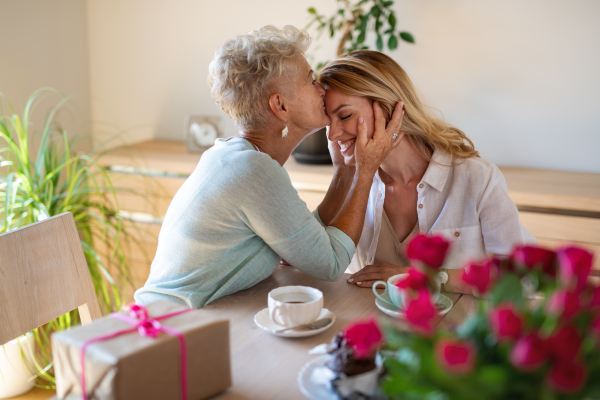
{"left": 0, "top": 332, "right": 35, "bottom": 399}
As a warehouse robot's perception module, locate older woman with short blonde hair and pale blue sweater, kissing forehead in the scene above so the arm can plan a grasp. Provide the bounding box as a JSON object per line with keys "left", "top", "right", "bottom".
{"left": 135, "top": 26, "right": 402, "bottom": 308}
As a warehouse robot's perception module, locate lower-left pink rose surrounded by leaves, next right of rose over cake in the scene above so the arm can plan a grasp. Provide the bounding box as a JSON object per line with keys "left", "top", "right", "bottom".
{"left": 435, "top": 338, "right": 476, "bottom": 375}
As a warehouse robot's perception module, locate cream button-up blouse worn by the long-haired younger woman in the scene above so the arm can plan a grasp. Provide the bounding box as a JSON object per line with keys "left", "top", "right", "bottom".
{"left": 346, "top": 150, "right": 537, "bottom": 273}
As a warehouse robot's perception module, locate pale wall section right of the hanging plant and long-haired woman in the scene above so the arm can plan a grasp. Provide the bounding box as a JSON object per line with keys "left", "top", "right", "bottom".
{"left": 396, "top": 0, "right": 600, "bottom": 172}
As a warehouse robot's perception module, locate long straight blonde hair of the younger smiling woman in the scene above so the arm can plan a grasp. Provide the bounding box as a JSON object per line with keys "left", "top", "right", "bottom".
{"left": 318, "top": 50, "right": 479, "bottom": 161}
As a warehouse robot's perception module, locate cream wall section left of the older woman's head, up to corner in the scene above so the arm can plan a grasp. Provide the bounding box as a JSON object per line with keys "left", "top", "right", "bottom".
{"left": 88, "top": 0, "right": 335, "bottom": 147}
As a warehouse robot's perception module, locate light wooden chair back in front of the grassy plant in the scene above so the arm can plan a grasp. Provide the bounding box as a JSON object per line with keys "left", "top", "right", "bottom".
{"left": 0, "top": 213, "right": 102, "bottom": 345}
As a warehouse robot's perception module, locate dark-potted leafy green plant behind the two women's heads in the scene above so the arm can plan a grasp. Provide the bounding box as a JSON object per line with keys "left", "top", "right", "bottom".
{"left": 294, "top": 0, "right": 415, "bottom": 164}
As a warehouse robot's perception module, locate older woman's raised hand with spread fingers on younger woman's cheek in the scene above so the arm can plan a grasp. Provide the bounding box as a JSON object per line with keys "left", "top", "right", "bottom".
{"left": 354, "top": 101, "right": 404, "bottom": 176}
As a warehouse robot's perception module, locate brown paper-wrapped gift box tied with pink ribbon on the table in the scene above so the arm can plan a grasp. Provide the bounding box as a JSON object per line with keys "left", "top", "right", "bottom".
{"left": 52, "top": 301, "right": 231, "bottom": 400}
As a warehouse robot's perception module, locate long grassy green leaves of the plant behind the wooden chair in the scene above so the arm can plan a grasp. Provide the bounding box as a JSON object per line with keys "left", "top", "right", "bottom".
{"left": 0, "top": 88, "right": 144, "bottom": 388}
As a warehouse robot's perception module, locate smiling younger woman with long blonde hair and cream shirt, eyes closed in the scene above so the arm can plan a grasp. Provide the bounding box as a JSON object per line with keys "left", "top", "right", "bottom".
{"left": 319, "top": 50, "right": 535, "bottom": 292}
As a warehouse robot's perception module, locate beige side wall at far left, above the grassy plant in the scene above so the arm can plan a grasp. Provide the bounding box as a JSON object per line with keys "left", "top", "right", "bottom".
{"left": 0, "top": 0, "right": 90, "bottom": 146}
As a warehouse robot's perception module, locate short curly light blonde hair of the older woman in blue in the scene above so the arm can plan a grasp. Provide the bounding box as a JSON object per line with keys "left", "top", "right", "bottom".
{"left": 208, "top": 25, "right": 311, "bottom": 130}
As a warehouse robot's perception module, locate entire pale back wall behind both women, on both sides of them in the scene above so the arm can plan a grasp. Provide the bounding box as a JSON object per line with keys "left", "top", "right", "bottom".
{"left": 87, "top": 0, "right": 600, "bottom": 172}
